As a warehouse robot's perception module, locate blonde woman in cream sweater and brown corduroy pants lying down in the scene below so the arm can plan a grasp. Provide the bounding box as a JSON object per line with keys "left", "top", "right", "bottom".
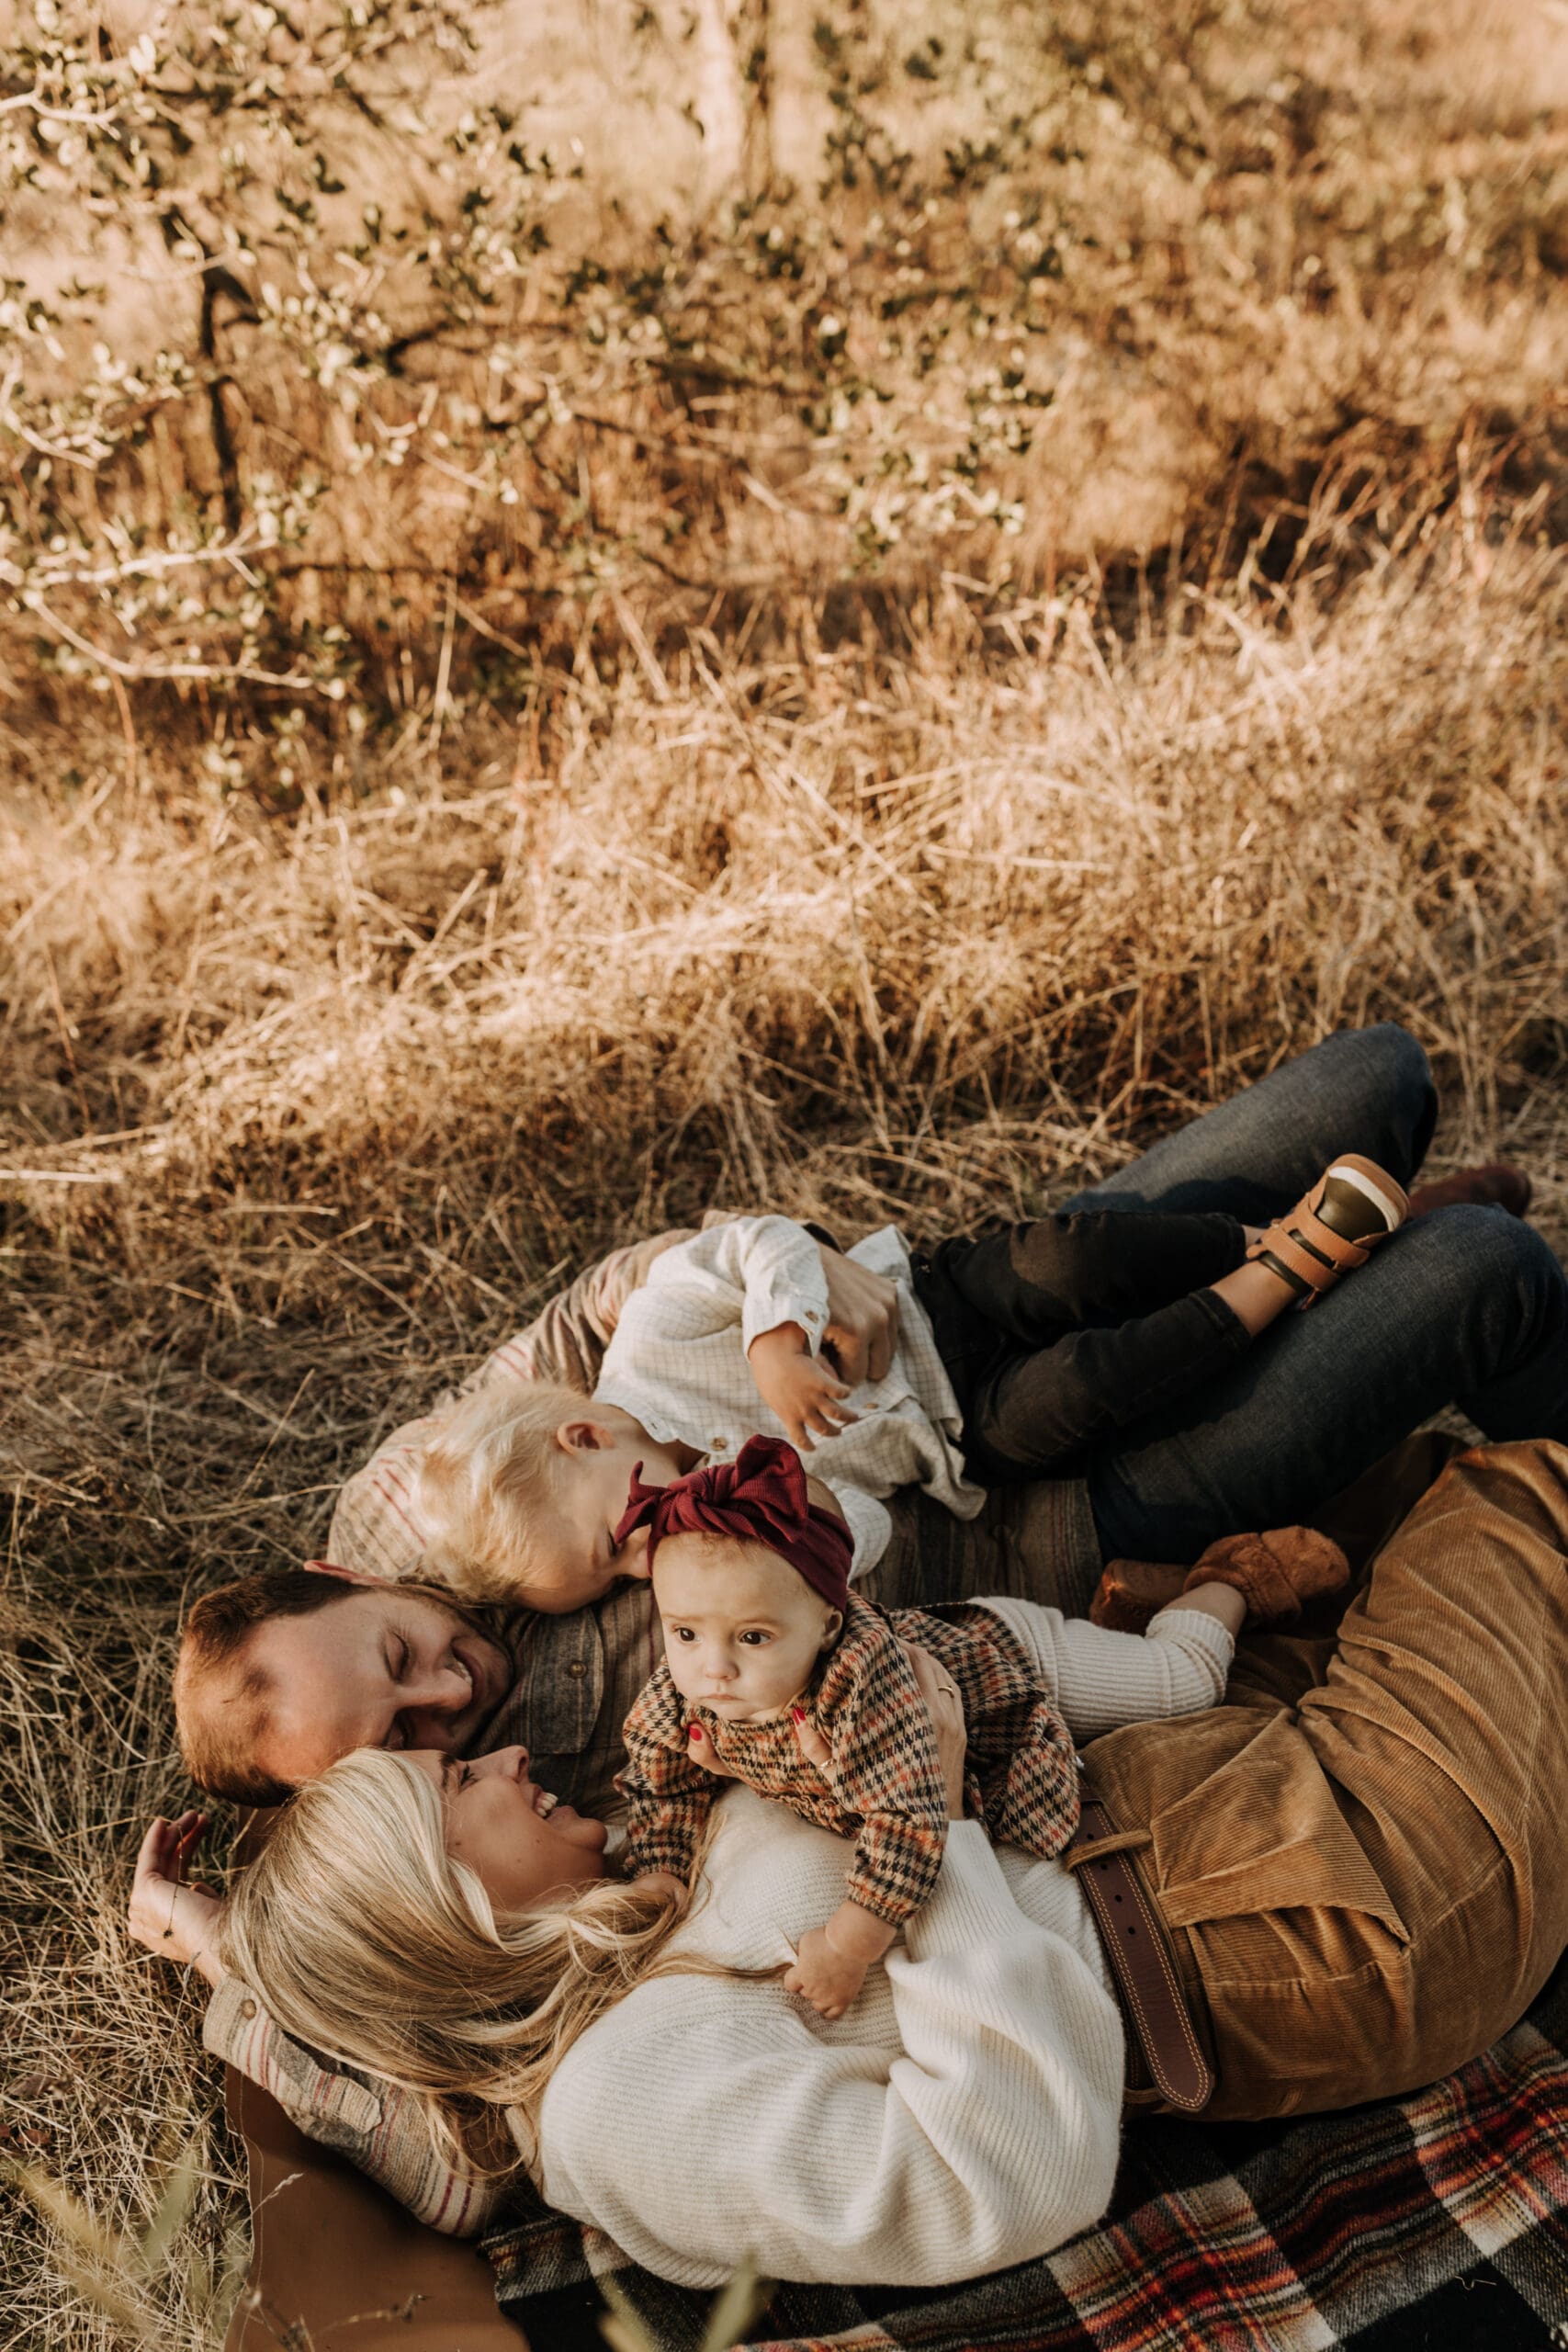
{"left": 131, "top": 1442, "right": 1568, "bottom": 2286}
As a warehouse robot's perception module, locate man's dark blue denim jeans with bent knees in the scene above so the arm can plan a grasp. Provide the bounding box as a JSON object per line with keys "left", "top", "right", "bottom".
{"left": 1067, "top": 1023, "right": 1568, "bottom": 1559}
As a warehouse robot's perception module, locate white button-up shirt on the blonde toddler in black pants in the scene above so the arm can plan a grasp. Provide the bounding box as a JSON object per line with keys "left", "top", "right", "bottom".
{"left": 594, "top": 1216, "right": 985, "bottom": 1576}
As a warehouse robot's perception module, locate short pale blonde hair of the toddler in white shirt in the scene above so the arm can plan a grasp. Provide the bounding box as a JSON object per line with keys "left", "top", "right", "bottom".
{"left": 413, "top": 1381, "right": 592, "bottom": 1601}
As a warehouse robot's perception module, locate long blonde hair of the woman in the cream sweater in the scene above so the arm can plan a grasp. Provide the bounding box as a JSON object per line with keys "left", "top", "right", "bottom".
{"left": 223, "top": 1747, "right": 700, "bottom": 2164}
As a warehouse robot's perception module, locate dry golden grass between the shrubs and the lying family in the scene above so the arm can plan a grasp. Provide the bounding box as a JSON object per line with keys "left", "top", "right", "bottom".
{"left": 0, "top": 529, "right": 1568, "bottom": 2345}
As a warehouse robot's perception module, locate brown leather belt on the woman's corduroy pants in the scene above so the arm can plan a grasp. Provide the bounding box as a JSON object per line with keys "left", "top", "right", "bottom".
{"left": 1063, "top": 1788, "right": 1213, "bottom": 2114}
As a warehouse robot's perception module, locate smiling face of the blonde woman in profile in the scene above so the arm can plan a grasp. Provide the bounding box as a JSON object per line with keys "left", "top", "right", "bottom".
{"left": 409, "top": 1747, "right": 609, "bottom": 1912}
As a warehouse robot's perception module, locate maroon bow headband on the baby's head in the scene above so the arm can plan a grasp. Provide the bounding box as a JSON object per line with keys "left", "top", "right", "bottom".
{"left": 616, "top": 1437, "right": 853, "bottom": 1609}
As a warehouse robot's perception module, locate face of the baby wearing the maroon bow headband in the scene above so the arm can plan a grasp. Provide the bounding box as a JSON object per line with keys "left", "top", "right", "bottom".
{"left": 653, "top": 1536, "right": 844, "bottom": 1724}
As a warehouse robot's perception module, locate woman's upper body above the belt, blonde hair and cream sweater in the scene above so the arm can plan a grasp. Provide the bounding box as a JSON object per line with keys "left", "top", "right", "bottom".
{"left": 192, "top": 1660, "right": 1122, "bottom": 2284}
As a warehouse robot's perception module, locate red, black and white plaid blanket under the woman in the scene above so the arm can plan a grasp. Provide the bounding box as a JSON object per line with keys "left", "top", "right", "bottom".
{"left": 487, "top": 1964, "right": 1568, "bottom": 2352}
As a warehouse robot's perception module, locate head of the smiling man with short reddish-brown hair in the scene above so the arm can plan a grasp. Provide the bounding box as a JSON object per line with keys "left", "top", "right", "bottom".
{"left": 244, "top": 1585, "right": 513, "bottom": 1785}
